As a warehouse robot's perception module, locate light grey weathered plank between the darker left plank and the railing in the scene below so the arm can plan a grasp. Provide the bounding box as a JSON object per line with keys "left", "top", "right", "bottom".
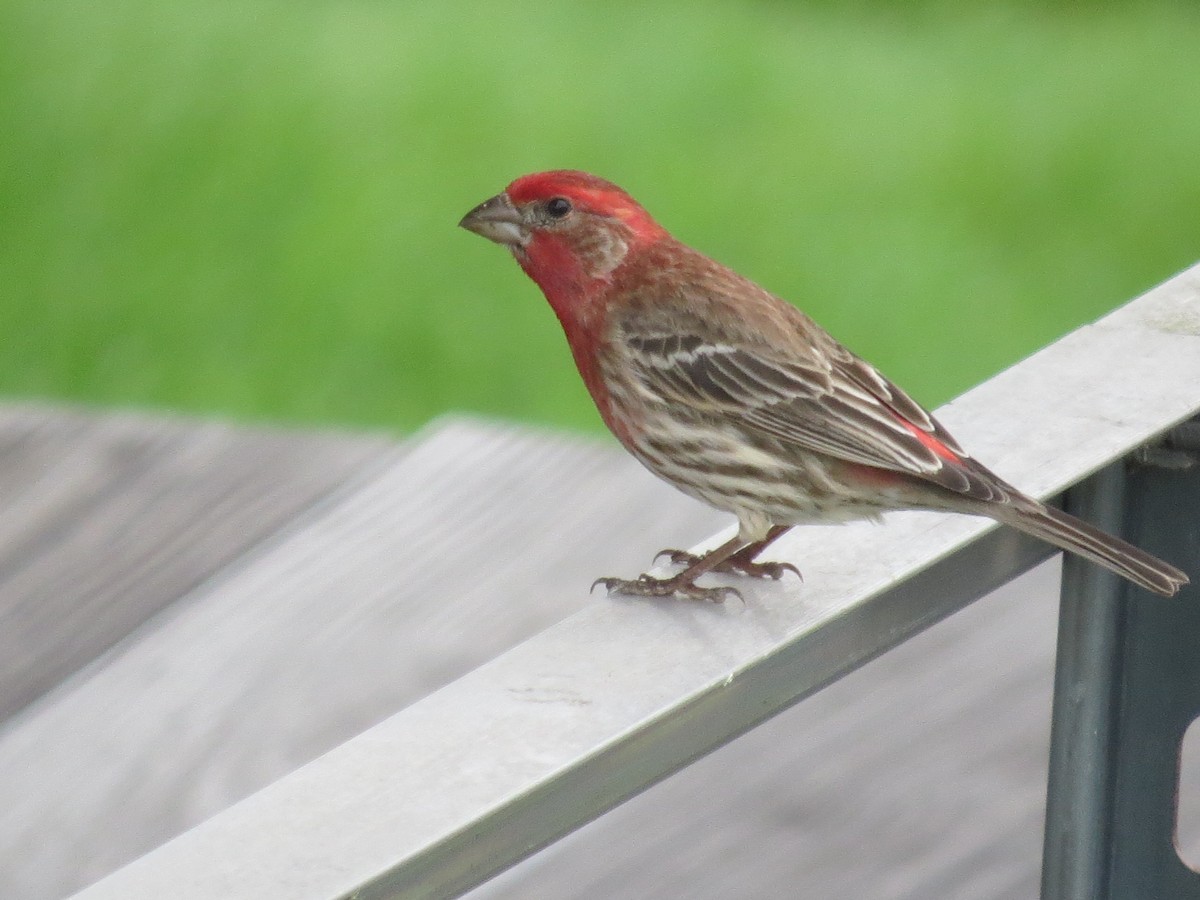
{"left": 0, "top": 421, "right": 724, "bottom": 900}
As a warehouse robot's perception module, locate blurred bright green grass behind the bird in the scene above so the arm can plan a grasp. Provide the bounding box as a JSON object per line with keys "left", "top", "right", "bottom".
{"left": 0, "top": 0, "right": 1200, "bottom": 431}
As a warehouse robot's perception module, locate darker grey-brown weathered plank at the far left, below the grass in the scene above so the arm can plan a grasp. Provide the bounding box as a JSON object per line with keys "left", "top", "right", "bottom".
{"left": 0, "top": 406, "right": 397, "bottom": 722}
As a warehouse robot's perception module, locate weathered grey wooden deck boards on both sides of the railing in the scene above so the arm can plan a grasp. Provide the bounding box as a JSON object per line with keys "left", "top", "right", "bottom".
{"left": 0, "top": 407, "right": 1200, "bottom": 900}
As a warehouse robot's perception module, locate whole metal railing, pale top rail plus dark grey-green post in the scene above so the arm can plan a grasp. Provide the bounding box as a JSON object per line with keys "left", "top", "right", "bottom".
{"left": 70, "top": 266, "right": 1200, "bottom": 900}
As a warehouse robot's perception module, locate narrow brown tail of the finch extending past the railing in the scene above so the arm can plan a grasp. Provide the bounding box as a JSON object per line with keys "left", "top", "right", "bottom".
{"left": 1003, "top": 504, "right": 1188, "bottom": 596}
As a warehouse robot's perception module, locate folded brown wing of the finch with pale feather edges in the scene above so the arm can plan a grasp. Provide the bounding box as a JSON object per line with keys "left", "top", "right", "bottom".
{"left": 614, "top": 301, "right": 1009, "bottom": 500}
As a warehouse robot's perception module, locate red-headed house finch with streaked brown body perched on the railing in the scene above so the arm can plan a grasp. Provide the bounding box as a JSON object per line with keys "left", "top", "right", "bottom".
{"left": 461, "top": 170, "right": 1188, "bottom": 601}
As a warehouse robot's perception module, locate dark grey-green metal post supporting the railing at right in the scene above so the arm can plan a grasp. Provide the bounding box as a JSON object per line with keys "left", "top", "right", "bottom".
{"left": 1042, "top": 422, "right": 1200, "bottom": 900}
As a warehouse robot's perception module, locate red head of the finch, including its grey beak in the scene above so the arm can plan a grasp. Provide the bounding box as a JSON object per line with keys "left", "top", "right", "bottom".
{"left": 460, "top": 169, "right": 666, "bottom": 304}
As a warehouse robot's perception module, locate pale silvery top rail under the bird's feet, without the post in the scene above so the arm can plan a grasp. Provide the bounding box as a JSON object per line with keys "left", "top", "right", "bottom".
{"left": 77, "top": 266, "right": 1200, "bottom": 900}
